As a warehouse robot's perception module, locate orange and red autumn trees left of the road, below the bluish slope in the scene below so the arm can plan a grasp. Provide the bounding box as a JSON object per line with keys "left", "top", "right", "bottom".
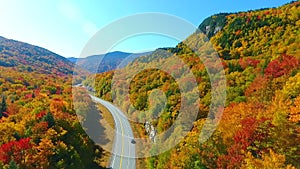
{"left": 0, "top": 67, "right": 108, "bottom": 169}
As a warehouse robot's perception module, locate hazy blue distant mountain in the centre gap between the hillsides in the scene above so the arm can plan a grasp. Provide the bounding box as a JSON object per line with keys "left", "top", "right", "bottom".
{"left": 68, "top": 51, "right": 152, "bottom": 73}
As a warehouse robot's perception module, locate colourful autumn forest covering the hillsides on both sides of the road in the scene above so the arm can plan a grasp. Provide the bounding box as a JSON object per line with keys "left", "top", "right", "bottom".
{"left": 0, "top": 1, "right": 300, "bottom": 169}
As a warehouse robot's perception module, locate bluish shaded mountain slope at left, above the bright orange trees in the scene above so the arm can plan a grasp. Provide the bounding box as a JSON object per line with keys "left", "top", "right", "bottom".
{"left": 0, "top": 36, "right": 82, "bottom": 74}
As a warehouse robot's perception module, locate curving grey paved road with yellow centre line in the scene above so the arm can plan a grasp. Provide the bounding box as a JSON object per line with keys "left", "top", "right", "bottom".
{"left": 90, "top": 95, "right": 136, "bottom": 169}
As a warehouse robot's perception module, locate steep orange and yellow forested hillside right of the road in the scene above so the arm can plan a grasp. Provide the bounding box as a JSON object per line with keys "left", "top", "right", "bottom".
{"left": 85, "top": 1, "right": 300, "bottom": 169}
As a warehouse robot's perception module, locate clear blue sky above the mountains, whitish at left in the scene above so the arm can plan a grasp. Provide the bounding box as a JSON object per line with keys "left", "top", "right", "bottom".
{"left": 0, "top": 0, "right": 290, "bottom": 57}
